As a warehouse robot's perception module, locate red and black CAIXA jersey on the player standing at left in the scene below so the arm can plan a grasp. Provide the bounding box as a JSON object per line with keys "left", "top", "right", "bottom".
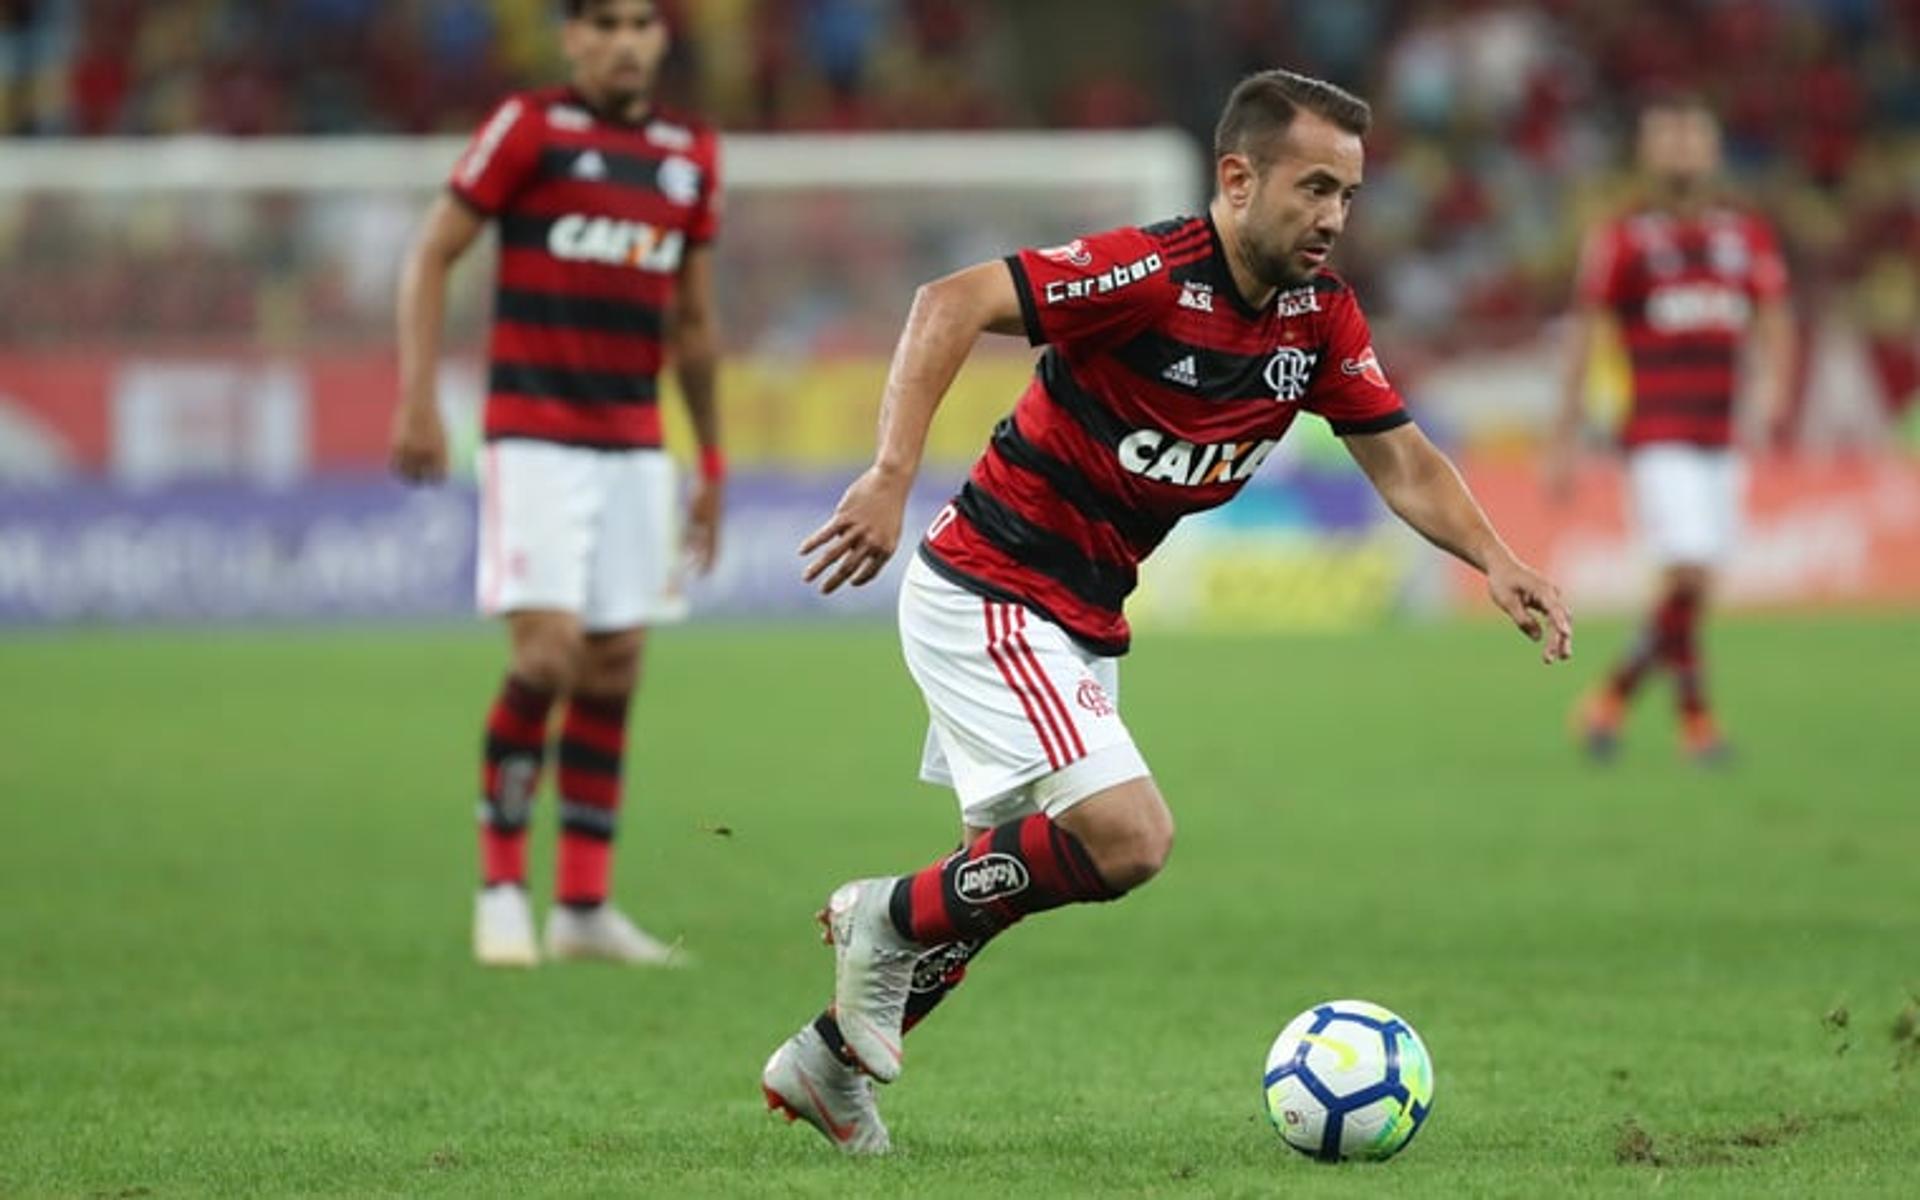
{"left": 449, "top": 88, "right": 720, "bottom": 449}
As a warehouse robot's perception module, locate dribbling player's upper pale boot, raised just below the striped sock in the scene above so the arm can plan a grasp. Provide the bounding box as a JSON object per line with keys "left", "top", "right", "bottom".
{"left": 820, "top": 877, "right": 925, "bottom": 1083}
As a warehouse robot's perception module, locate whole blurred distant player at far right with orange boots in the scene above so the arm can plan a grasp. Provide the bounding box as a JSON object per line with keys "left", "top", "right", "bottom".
{"left": 1548, "top": 100, "right": 1793, "bottom": 762}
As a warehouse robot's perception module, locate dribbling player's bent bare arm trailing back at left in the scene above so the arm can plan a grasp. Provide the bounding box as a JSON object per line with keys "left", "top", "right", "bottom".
{"left": 801, "top": 261, "right": 1027, "bottom": 591}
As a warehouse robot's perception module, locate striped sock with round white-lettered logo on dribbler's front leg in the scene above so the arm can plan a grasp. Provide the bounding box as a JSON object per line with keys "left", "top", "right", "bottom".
{"left": 891, "top": 812, "right": 1119, "bottom": 947}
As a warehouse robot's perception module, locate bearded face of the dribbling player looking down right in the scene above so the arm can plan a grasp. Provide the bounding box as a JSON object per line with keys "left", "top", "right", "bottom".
{"left": 1223, "top": 111, "right": 1365, "bottom": 288}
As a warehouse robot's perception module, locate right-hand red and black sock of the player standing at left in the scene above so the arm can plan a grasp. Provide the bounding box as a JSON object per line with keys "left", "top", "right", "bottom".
{"left": 553, "top": 695, "right": 628, "bottom": 908}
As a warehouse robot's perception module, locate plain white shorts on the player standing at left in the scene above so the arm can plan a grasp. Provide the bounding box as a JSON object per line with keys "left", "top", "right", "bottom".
{"left": 478, "top": 440, "right": 687, "bottom": 632}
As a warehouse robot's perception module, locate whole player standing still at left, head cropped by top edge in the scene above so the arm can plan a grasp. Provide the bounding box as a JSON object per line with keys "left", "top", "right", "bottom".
{"left": 394, "top": 0, "right": 724, "bottom": 966}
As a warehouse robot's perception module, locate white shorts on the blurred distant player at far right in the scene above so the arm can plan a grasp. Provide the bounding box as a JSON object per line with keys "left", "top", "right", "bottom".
{"left": 1626, "top": 442, "right": 1745, "bottom": 566}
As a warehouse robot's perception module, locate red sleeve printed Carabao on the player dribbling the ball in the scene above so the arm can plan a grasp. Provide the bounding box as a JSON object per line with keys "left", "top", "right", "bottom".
{"left": 1006, "top": 228, "right": 1173, "bottom": 348}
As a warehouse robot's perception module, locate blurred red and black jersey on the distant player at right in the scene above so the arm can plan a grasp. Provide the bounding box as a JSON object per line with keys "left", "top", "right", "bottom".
{"left": 1580, "top": 207, "right": 1788, "bottom": 445}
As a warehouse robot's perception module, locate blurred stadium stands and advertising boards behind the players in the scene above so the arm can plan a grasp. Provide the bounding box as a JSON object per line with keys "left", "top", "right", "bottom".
{"left": 0, "top": 0, "right": 1920, "bottom": 628}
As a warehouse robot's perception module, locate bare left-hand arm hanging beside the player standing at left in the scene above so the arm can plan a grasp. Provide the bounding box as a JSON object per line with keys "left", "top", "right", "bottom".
{"left": 390, "top": 194, "right": 486, "bottom": 482}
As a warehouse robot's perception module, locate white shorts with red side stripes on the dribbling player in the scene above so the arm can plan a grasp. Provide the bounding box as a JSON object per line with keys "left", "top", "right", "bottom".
{"left": 900, "top": 553, "right": 1148, "bottom": 829}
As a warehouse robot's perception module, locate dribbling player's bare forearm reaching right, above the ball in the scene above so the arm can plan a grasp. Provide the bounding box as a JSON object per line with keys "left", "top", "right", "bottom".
{"left": 1344, "top": 422, "right": 1572, "bottom": 662}
